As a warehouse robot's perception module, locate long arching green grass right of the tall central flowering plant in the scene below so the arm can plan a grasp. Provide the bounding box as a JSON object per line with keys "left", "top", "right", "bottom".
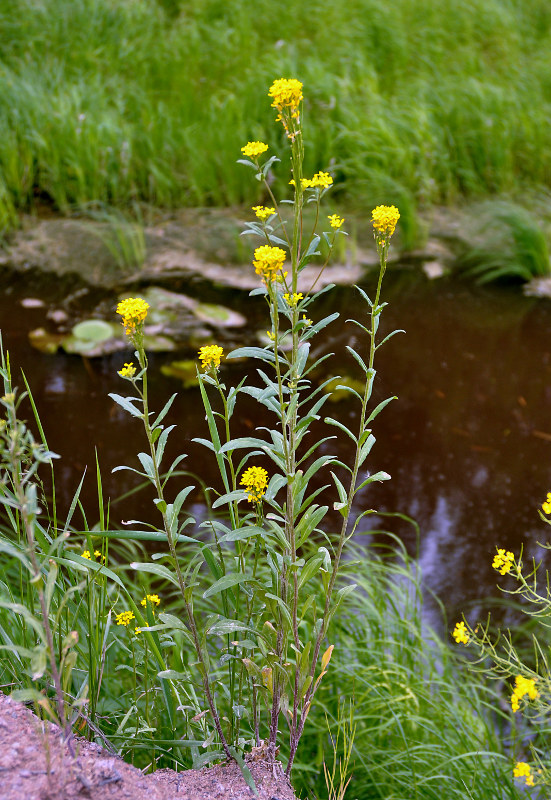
{"left": 295, "top": 537, "right": 523, "bottom": 800}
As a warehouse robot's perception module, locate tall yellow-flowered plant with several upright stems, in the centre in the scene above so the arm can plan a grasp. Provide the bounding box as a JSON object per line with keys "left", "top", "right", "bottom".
{"left": 112, "top": 79, "right": 399, "bottom": 775}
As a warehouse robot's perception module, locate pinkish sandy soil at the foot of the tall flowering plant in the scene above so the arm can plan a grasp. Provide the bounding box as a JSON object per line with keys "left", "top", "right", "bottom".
{"left": 0, "top": 692, "right": 296, "bottom": 800}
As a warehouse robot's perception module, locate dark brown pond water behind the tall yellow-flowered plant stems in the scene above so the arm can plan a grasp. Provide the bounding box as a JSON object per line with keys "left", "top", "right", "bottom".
{"left": 0, "top": 268, "right": 551, "bottom": 632}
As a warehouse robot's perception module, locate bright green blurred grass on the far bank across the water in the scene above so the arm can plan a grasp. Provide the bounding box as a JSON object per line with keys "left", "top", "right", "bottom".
{"left": 0, "top": 0, "right": 551, "bottom": 225}
